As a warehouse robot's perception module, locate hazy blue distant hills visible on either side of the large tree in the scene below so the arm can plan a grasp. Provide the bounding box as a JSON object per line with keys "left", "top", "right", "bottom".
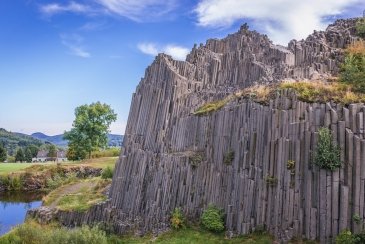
{"left": 31, "top": 132, "right": 123, "bottom": 147}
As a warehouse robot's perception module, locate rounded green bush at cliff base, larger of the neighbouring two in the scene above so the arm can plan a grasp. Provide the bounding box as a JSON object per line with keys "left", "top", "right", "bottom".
{"left": 200, "top": 204, "right": 224, "bottom": 232}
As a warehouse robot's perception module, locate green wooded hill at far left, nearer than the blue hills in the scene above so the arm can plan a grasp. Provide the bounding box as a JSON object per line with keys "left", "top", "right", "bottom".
{"left": 0, "top": 128, "right": 46, "bottom": 155}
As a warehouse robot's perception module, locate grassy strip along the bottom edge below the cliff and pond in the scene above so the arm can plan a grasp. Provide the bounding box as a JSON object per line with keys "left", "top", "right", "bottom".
{"left": 0, "top": 221, "right": 273, "bottom": 244}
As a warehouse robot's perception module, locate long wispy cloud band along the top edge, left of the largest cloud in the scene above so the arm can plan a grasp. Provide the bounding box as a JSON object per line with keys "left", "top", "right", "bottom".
{"left": 40, "top": 0, "right": 177, "bottom": 21}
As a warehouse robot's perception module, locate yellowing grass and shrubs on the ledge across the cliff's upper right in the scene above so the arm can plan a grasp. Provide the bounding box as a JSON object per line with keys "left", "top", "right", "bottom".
{"left": 193, "top": 39, "right": 365, "bottom": 115}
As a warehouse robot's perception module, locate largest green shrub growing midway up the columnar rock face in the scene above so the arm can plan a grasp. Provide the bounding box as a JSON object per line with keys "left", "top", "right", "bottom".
{"left": 314, "top": 127, "right": 341, "bottom": 171}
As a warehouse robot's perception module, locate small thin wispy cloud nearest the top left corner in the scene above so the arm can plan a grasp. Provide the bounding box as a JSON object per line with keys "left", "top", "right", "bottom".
{"left": 40, "top": 2, "right": 92, "bottom": 15}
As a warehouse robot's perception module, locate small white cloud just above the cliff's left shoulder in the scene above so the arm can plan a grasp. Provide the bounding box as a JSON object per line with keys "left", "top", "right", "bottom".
{"left": 137, "top": 43, "right": 190, "bottom": 60}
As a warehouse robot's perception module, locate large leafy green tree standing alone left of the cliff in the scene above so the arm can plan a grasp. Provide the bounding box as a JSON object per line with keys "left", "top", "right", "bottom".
{"left": 64, "top": 102, "right": 117, "bottom": 160}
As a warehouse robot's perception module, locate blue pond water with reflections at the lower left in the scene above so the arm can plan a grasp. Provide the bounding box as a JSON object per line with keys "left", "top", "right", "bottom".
{"left": 0, "top": 192, "right": 44, "bottom": 235}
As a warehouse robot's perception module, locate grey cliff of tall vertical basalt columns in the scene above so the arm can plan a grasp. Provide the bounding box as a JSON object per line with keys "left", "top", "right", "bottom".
{"left": 27, "top": 19, "right": 365, "bottom": 241}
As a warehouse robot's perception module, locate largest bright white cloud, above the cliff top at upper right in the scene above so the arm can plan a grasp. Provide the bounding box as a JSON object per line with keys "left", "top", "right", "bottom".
{"left": 194, "top": 0, "right": 364, "bottom": 44}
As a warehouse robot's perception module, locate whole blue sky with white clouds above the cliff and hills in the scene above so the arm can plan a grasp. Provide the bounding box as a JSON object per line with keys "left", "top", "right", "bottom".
{"left": 0, "top": 0, "right": 365, "bottom": 135}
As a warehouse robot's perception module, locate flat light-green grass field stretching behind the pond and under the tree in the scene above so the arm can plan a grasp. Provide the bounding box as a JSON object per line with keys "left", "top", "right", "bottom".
{"left": 0, "top": 157, "right": 118, "bottom": 175}
